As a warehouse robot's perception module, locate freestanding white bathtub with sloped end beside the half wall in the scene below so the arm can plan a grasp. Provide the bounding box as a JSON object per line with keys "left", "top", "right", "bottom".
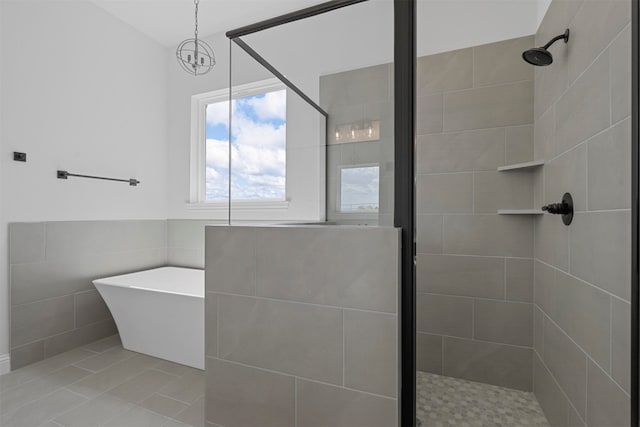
{"left": 93, "top": 267, "right": 204, "bottom": 369}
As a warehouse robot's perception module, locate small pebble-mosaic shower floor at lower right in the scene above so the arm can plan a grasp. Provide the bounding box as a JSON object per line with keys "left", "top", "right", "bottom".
{"left": 416, "top": 372, "right": 549, "bottom": 427}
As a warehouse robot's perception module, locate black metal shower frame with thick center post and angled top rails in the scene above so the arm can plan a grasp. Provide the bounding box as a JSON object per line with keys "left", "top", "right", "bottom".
{"left": 226, "top": 0, "right": 416, "bottom": 427}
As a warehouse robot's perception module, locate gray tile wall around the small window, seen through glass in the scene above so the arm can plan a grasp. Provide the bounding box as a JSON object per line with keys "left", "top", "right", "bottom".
{"left": 320, "top": 64, "right": 396, "bottom": 226}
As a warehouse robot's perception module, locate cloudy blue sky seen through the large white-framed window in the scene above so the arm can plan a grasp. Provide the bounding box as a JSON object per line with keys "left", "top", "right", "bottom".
{"left": 206, "top": 90, "right": 287, "bottom": 200}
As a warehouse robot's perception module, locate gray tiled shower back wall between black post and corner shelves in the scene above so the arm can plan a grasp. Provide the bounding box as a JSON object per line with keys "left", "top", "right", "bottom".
{"left": 416, "top": 36, "right": 534, "bottom": 390}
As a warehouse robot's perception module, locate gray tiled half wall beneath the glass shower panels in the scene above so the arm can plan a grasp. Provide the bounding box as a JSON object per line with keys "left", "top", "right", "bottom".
{"left": 205, "top": 226, "right": 399, "bottom": 427}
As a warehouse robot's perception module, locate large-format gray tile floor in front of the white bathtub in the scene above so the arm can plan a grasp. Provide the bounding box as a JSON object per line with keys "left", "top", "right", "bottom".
{"left": 0, "top": 335, "right": 204, "bottom": 427}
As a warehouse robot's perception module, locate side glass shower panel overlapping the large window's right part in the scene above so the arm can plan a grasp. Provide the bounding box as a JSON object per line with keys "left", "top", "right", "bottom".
{"left": 230, "top": 39, "right": 326, "bottom": 223}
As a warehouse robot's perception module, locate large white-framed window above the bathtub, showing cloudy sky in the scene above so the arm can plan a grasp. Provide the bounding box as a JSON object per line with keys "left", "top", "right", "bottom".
{"left": 191, "top": 80, "right": 287, "bottom": 208}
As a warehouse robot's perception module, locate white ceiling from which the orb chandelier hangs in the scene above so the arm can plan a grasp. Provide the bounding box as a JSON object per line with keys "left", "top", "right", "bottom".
{"left": 89, "top": 0, "right": 324, "bottom": 46}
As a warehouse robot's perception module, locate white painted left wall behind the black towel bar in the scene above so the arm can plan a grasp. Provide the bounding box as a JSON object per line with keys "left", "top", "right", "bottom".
{"left": 0, "top": 0, "right": 167, "bottom": 362}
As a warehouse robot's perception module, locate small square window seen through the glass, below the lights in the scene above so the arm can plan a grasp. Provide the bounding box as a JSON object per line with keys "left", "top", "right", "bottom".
{"left": 339, "top": 165, "right": 380, "bottom": 213}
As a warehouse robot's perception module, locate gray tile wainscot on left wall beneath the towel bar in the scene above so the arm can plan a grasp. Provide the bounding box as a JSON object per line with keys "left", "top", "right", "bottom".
{"left": 9, "top": 220, "right": 167, "bottom": 369}
